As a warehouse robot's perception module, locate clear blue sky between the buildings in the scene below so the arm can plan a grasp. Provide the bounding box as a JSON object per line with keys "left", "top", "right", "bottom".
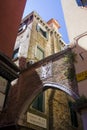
{"left": 23, "top": 0, "right": 69, "bottom": 44}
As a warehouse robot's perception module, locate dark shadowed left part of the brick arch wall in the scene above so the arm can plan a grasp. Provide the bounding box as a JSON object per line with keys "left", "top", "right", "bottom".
{"left": 0, "top": 69, "right": 42, "bottom": 124}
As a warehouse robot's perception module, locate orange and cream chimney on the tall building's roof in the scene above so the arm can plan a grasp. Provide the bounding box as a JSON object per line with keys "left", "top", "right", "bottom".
{"left": 47, "top": 18, "right": 60, "bottom": 31}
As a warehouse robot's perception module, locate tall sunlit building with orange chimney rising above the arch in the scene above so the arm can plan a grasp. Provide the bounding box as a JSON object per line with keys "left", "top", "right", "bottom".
{"left": 13, "top": 12, "right": 65, "bottom": 67}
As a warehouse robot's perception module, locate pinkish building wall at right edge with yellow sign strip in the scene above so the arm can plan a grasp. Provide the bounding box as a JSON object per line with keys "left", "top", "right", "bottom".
{"left": 72, "top": 32, "right": 87, "bottom": 130}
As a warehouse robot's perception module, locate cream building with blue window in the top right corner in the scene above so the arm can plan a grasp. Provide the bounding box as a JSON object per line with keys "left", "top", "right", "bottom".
{"left": 61, "top": 0, "right": 87, "bottom": 42}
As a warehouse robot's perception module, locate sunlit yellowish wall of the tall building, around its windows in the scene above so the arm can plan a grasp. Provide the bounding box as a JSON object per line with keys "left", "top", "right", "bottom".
{"left": 27, "top": 18, "right": 62, "bottom": 61}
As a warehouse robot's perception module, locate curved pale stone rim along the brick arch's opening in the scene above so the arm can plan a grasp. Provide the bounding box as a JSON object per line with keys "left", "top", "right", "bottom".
{"left": 18, "top": 82, "right": 79, "bottom": 122}
